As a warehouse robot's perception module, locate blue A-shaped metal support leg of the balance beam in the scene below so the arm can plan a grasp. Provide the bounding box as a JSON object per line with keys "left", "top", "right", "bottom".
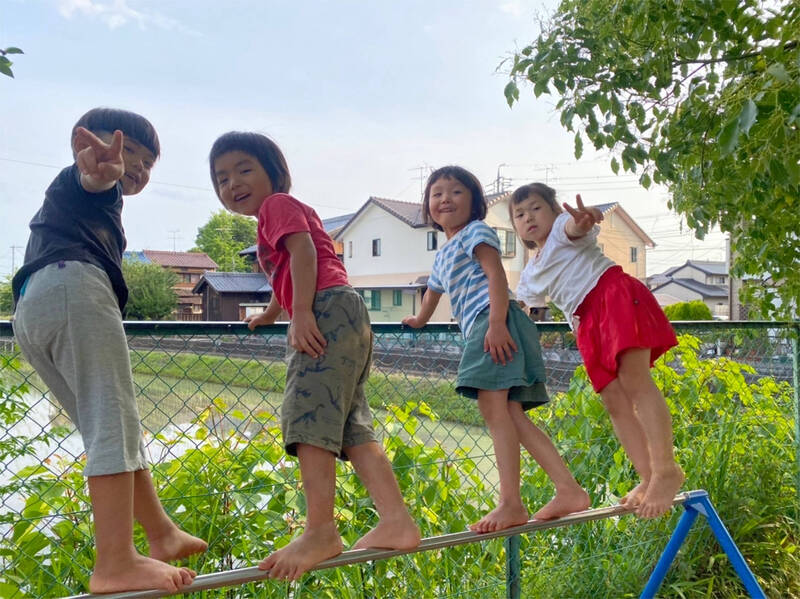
{"left": 640, "top": 491, "right": 767, "bottom": 599}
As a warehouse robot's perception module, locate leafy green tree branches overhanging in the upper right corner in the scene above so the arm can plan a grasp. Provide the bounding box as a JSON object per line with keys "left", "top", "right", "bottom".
{"left": 505, "top": 0, "right": 800, "bottom": 316}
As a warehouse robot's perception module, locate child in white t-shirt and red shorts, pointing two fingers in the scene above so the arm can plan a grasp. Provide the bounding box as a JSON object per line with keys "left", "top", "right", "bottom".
{"left": 509, "top": 183, "right": 684, "bottom": 518}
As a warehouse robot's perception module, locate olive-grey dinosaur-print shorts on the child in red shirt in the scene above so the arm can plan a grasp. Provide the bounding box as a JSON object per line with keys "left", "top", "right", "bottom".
{"left": 281, "top": 286, "right": 377, "bottom": 459}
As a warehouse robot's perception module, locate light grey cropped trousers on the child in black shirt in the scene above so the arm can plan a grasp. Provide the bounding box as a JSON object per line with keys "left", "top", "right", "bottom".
{"left": 13, "top": 261, "right": 147, "bottom": 476}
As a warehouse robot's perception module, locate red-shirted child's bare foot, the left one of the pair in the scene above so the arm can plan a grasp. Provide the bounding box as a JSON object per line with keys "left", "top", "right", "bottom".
{"left": 258, "top": 522, "right": 344, "bottom": 580}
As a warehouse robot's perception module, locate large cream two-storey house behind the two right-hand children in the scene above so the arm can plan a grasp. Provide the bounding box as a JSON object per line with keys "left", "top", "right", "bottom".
{"left": 335, "top": 192, "right": 655, "bottom": 322}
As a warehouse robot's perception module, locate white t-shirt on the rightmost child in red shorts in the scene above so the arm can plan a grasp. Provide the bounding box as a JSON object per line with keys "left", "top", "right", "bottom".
{"left": 516, "top": 212, "right": 615, "bottom": 327}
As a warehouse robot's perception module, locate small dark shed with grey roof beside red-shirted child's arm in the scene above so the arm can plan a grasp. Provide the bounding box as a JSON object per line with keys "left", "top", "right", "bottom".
{"left": 192, "top": 272, "right": 276, "bottom": 321}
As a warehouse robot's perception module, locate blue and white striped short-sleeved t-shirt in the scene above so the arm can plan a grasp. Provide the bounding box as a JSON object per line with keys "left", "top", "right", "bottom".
{"left": 428, "top": 220, "right": 511, "bottom": 337}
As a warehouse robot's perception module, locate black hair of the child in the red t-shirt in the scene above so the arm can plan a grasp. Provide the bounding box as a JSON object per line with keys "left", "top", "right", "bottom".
{"left": 208, "top": 131, "right": 292, "bottom": 196}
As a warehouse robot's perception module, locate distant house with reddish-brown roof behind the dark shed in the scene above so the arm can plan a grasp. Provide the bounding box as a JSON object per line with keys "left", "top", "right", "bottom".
{"left": 123, "top": 250, "right": 217, "bottom": 320}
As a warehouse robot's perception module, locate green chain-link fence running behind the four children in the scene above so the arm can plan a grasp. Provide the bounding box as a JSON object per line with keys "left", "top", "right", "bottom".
{"left": 0, "top": 322, "right": 800, "bottom": 599}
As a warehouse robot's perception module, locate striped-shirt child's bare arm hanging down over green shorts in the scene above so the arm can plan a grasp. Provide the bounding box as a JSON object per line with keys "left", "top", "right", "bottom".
{"left": 475, "top": 243, "right": 517, "bottom": 364}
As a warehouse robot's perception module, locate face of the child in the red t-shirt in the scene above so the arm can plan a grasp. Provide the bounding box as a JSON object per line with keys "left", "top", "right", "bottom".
{"left": 214, "top": 150, "right": 273, "bottom": 216}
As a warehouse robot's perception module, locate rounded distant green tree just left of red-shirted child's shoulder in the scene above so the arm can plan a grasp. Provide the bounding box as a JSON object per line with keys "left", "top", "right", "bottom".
{"left": 195, "top": 210, "right": 256, "bottom": 272}
